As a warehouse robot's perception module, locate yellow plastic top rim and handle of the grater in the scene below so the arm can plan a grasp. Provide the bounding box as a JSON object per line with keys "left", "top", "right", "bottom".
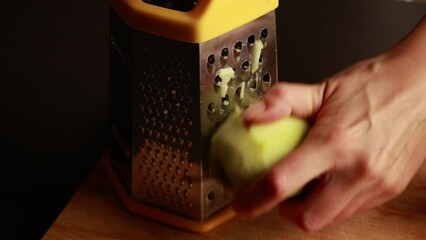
{"left": 110, "top": 0, "right": 279, "bottom": 43}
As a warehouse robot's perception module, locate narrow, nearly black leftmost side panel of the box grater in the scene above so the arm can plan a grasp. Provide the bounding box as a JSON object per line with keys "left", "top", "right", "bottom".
{"left": 109, "top": 9, "right": 133, "bottom": 190}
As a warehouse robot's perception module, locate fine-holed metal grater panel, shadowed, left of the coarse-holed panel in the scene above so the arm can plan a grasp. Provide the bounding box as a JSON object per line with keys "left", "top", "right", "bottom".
{"left": 132, "top": 30, "right": 202, "bottom": 221}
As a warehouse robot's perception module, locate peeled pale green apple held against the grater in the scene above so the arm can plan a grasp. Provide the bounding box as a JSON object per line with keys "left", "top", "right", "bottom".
{"left": 209, "top": 111, "right": 310, "bottom": 189}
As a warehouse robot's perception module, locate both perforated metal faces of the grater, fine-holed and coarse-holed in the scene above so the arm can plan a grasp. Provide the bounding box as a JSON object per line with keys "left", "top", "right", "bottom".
{"left": 108, "top": 12, "right": 277, "bottom": 221}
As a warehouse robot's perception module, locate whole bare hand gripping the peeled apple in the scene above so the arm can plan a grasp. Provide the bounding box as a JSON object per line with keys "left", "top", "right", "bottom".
{"left": 233, "top": 16, "right": 426, "bottom": 231}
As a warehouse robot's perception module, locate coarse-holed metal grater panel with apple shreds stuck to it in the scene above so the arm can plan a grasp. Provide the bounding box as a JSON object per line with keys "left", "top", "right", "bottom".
{"left": 200, "top": 11, "right": 278, "bottom": 219}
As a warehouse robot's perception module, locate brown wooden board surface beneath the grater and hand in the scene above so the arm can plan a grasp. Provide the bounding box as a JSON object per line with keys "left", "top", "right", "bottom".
{"left": 43, "top": 157, "right": 426, "bottom": 240}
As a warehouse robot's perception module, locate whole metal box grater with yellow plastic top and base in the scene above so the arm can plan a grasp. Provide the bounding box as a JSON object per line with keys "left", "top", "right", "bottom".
{"left": 109, "top": 0, "right": 278, "bottom": 231}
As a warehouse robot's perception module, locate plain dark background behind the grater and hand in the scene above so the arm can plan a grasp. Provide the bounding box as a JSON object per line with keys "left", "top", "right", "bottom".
{"left": 0, "top": 0, "right": 426, "bottom": 239}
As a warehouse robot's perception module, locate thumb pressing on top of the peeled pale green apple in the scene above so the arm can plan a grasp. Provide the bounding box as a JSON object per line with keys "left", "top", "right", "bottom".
{"left": 243, "top": 82, "right": 325, "bottom": 125}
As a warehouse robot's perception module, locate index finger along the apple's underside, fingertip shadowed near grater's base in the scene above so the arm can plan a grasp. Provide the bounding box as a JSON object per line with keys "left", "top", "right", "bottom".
{"left": 233, "top": 140, "right": 331, "bottom": 217}
